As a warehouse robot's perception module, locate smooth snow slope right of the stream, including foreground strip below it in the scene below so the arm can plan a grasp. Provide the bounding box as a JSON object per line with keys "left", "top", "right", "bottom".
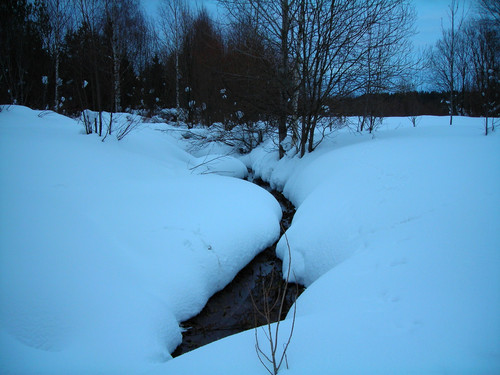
{"left": 161, "top": 117, "right": 500, "bottom": 374}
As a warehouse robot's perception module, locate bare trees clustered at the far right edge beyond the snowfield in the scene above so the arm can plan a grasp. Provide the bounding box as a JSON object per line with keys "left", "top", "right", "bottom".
{"left": 426, "top": 0, "right": 500, "bottom": 125}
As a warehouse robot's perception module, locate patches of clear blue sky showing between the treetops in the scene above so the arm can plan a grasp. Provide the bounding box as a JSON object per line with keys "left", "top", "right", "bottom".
{"left": 141, "top": 0, "right": 476, "bottom": 49}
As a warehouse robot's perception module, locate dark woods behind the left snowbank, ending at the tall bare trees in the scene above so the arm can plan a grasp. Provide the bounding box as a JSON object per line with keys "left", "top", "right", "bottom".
{"left": 0, "top": 0, "right": 276, "bottom": 125}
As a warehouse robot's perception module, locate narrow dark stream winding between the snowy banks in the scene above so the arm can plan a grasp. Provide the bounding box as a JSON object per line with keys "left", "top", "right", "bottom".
{"left": 172, "top": 171, "right": 304, "bottom": 357}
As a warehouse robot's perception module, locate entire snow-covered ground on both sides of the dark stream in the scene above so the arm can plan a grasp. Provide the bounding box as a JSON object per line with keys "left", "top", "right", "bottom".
{"left": 0, "top": 107, "right": 500, "bottom": 375}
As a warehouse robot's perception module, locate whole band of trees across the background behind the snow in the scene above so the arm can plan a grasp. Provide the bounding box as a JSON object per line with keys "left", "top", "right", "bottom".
{"left": 0, "top": 0, "right": 500, "bottom": 155}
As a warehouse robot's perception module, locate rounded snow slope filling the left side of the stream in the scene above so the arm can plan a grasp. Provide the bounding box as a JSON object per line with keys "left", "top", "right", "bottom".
{"left": 0, "top": 106, "right": 281, "bottom": 374}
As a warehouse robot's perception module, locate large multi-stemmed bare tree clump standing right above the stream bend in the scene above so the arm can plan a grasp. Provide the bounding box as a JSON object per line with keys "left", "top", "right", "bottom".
{"left": 220, "top": 0, "right": 412, "bottom": 157}
